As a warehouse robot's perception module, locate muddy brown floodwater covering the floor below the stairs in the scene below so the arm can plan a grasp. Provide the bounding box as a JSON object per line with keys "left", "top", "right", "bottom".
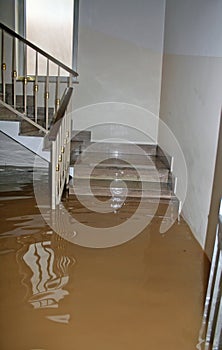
{"left": 0, "top": 168, "right": 209, "bottom": 350}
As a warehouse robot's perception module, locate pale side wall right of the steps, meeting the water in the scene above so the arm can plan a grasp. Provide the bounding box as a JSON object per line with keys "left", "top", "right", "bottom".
{"left": 159, "top": 0, "right": 222, "bottom": 247}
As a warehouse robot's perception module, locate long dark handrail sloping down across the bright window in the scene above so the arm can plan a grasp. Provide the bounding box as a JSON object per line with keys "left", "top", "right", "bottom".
{"left": 0, "top": 23, "right": 78, "bottom": 77}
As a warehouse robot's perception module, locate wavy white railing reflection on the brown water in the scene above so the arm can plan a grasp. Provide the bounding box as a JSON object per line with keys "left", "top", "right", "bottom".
{"left": 16, "top": 231, "right": 75, "bottom": 323}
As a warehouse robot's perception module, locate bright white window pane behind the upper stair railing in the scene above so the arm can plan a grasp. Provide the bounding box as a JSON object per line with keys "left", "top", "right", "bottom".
{"left": 26, "top": 0, "right": 74, "bottom": 75}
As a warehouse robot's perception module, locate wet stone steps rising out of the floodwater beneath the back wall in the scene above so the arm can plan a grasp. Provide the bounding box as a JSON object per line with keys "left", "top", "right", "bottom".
{"left": 68, "top": 132, "right": 179, "bottom": 216}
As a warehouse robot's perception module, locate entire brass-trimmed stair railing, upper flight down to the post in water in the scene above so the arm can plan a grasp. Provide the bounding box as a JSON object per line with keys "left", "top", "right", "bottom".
{"left": 0, "top": 23, "right": 78, "bottom": 209}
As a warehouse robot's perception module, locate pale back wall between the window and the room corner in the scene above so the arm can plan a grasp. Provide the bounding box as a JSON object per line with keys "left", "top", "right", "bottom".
{"left": 73, "top": 0, "right": 165, "bottom": 142}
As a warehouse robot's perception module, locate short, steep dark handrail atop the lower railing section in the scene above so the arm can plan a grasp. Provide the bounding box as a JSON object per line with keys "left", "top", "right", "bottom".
{"left": 48, "top": 87, "right": 73, "bottom": 141}
